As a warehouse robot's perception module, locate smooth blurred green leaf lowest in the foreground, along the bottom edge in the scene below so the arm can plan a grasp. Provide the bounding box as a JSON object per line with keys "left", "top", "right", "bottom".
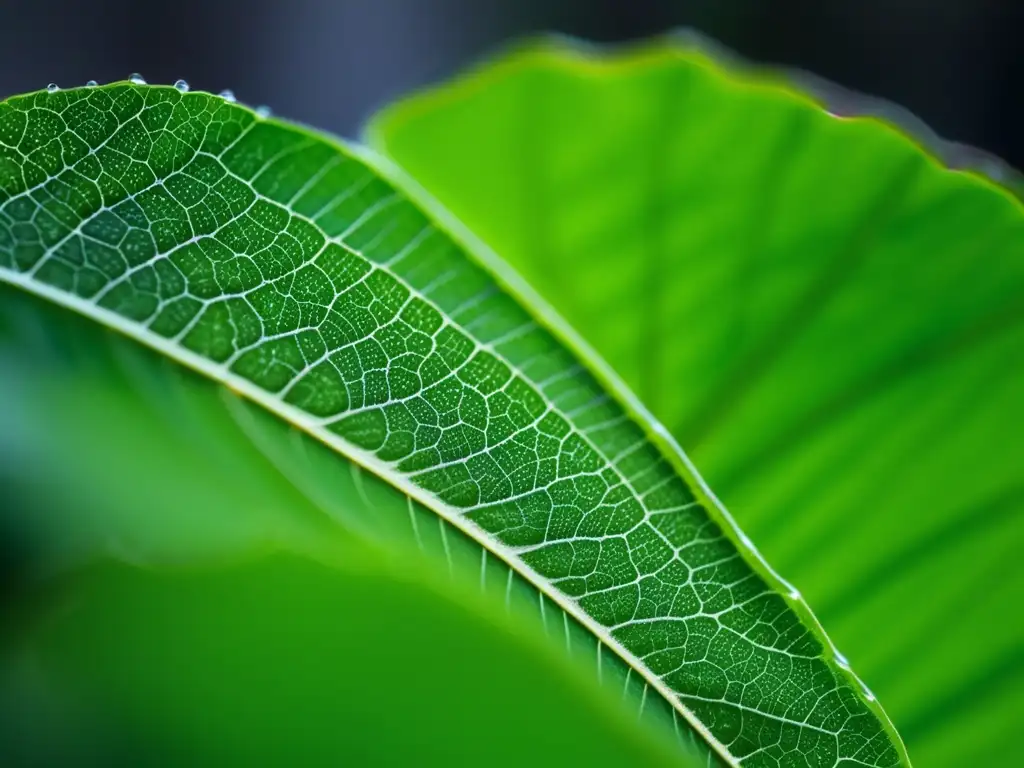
{"left": 0, "top": 552, "right": 679, "bottom": 768}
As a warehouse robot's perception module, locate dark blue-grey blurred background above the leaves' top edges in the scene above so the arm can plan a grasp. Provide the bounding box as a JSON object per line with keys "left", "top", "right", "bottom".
{"left": 0, "top": 0, "right": 1024, "bottom": 169}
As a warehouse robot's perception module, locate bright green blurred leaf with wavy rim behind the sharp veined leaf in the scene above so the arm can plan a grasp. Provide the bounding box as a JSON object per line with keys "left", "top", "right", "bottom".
{"left": 370, "top": 42, "right": 1024, "bottom": 766}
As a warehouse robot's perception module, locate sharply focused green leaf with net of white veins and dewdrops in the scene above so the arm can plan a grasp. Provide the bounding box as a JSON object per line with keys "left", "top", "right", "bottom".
{"left": 0, "top": 78, "right": 905, "bottom": 766}
